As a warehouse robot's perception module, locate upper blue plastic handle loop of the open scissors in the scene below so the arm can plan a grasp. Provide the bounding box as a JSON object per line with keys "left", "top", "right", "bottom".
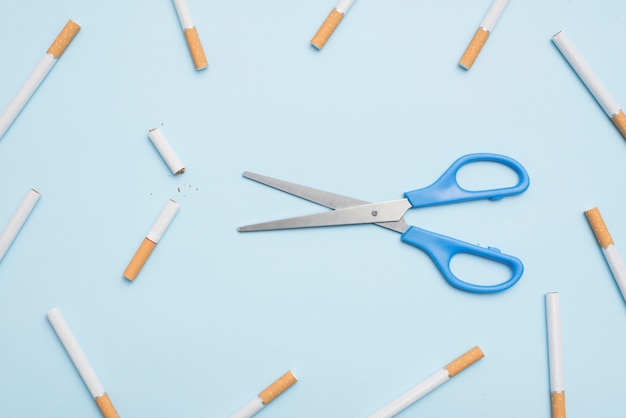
{"left": 404, "top": 153, "right": 530, "bottom": 208}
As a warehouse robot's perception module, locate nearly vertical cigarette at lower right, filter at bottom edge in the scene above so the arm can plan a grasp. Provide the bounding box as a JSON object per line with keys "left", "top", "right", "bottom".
{"left": 546, "top": 292, "right": 565, "bottom": 418}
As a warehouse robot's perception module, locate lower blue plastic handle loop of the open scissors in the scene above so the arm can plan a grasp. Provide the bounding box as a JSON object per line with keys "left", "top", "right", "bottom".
{"left": 400, "top": 226, "right": 524, "bottom": 293}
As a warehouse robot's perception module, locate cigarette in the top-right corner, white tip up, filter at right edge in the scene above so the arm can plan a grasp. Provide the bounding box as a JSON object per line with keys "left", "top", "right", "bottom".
{"left": 552, "top": 31, "right": 626, "bottom": 138}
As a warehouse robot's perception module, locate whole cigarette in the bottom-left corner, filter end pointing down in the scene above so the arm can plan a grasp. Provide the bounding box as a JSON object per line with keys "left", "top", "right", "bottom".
{"left": 47, "top": 308, "right": 119, "bottom": 418}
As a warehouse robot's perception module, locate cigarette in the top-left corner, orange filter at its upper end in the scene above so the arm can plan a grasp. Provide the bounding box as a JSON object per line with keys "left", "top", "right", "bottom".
{"left": 0, "top": 20, "right": 80, "bottom": 139}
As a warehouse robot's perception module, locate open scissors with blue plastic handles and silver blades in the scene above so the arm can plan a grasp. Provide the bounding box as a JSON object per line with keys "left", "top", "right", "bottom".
{"left": 238, "top": 153, "right": 530, "bottom": 293}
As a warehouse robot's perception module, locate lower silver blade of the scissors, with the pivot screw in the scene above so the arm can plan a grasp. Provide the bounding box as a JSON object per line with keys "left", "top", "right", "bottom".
{"left": 238, "top": 199, "right": 411, "bottom": 232}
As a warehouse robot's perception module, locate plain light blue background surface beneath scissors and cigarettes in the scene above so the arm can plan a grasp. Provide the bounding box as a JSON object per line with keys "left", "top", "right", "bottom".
{"left": 0, "top": 0, "right": 626, "bottom": 418}
